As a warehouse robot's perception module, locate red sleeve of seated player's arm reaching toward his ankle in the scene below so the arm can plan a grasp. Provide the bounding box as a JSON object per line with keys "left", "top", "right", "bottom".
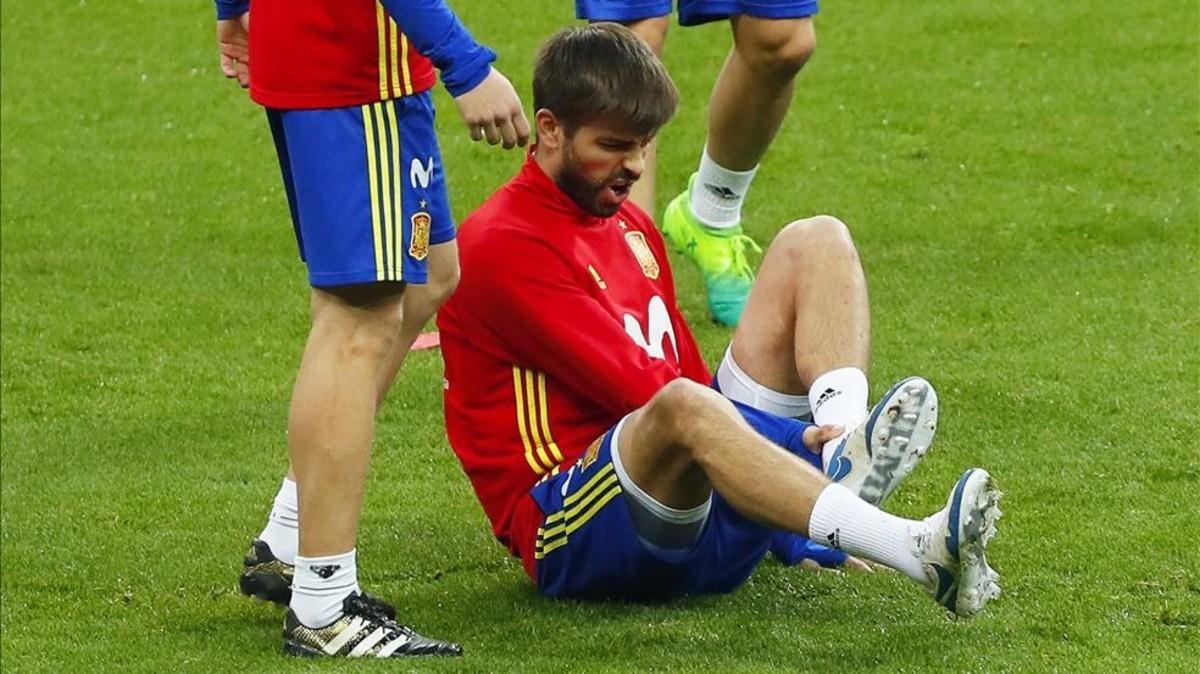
{"left": 458, "top": 231, "right": 691, "bottom": 414}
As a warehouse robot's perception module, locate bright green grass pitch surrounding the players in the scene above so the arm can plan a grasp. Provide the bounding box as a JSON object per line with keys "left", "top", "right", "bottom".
{"left": 0, "top": 0, "right": 1200, "bottom": 673}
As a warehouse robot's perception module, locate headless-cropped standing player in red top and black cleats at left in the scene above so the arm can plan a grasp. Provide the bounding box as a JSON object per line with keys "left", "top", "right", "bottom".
{"left": 216, "top": 0, "right": 529, "bottom": 657}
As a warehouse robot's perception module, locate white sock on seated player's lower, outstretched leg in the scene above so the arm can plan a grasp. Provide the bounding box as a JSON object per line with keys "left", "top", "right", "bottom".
{"left": 809, "top": 485, "right": 929, "bottom": 586}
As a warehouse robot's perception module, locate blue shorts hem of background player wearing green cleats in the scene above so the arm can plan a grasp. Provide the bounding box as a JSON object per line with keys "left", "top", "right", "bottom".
{"left": 575, "top": 0, "right": 817, "bottom": 25}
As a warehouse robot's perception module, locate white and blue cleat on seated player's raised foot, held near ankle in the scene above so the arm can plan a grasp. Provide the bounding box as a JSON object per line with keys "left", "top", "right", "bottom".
{"left": 826, "top": 377, "right": 937, "bottom": 506}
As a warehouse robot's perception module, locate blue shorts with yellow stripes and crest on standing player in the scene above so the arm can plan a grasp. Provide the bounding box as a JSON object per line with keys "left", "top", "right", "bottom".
{"left": 266, "top": 91, "right": 455, "bottom": 287}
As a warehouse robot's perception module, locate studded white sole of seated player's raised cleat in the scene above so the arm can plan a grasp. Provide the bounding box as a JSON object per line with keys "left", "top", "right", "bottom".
{"left": 858, "top": 377, "right": 937, "bottom": 506}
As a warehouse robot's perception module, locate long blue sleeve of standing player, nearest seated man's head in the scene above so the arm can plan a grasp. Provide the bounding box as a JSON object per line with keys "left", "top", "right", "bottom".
{"left": 381, "top": 0, "right": 496, "bottom": 96}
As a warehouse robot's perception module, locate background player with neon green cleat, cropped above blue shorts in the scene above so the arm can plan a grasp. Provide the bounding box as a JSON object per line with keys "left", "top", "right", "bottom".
{"left": 575, "top": 0, "right": 817, "bottom": 325}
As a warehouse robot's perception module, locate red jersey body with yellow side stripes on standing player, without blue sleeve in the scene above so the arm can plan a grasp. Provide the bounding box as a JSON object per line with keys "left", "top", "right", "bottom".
{"left": 250, "top": 0, "right": 437, "bottom": 109}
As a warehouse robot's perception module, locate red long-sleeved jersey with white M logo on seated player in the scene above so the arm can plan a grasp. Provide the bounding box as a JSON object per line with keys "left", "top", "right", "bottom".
{"left": 438, "top": 156, "right": 710, "bottom": 576}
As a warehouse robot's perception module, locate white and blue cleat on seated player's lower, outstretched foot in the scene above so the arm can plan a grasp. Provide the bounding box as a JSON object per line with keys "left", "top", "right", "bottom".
{"left": 913, "top": 468, "right": 1002, "bottom": 618}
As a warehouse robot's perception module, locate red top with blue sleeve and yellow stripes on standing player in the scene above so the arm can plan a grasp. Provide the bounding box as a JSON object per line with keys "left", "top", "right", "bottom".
{"left": 250, "top": 0, "right": 496, "bottom": 109}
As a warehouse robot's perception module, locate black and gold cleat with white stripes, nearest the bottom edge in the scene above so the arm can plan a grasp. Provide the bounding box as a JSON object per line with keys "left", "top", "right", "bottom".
{"left": 283, "top": 592, "right": 462, "bottom": 657}
